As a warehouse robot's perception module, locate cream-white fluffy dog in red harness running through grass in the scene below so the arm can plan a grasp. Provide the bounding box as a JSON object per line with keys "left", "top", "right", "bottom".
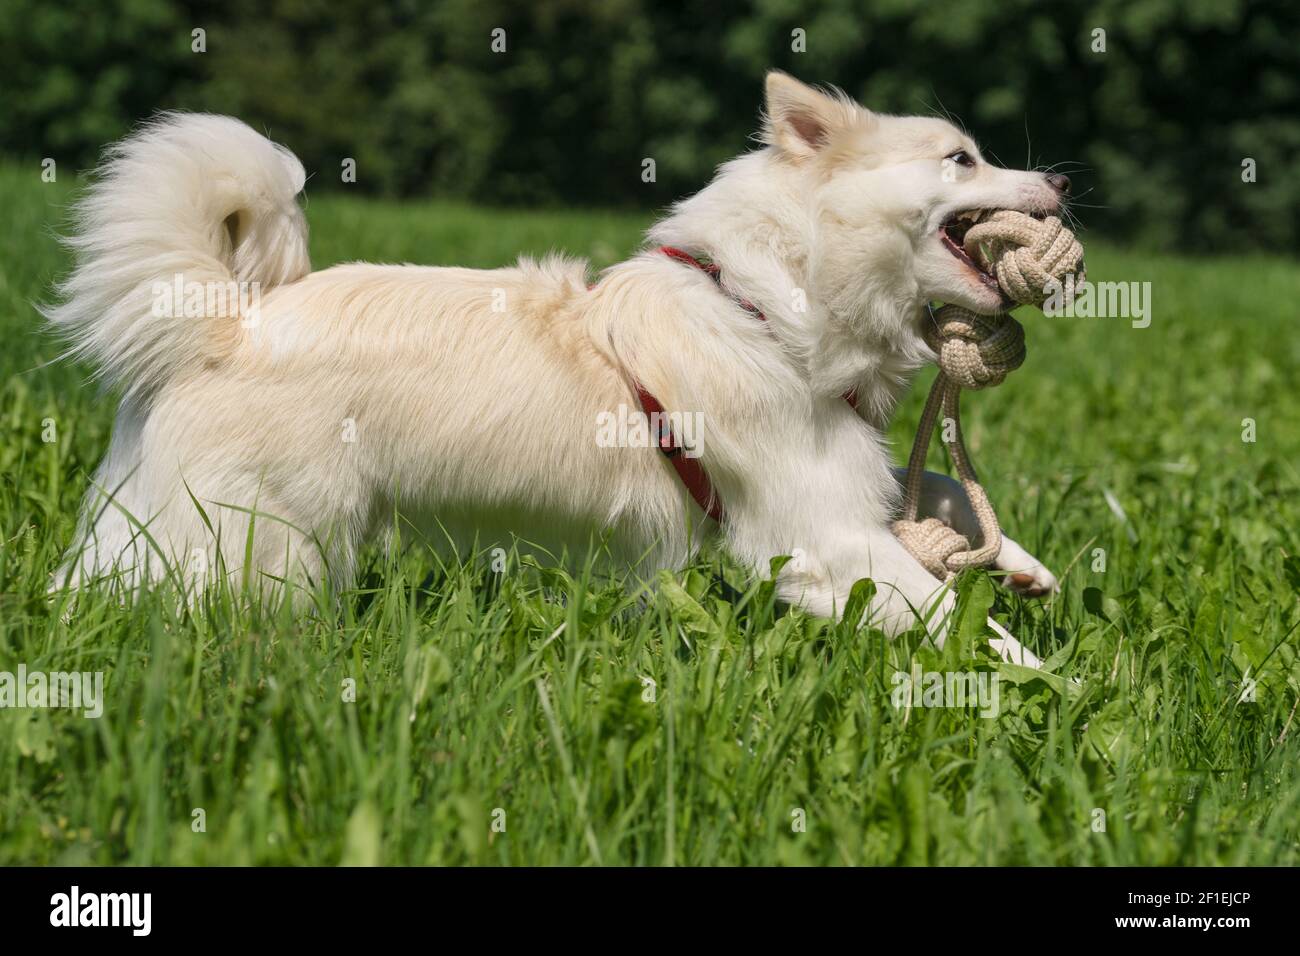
{"left": 46, "top": 72, "right": 1069, "bottom": 666}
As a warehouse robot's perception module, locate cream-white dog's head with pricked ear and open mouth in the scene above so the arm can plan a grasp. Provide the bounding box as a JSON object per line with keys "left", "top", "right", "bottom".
{"left": 763, "top": 72, "right": 1070, "bottom": 313}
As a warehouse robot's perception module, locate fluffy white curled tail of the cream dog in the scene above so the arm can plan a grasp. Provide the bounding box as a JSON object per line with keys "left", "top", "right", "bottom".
{"left": 43, "top": 113, "right": 311, "bottom": 395}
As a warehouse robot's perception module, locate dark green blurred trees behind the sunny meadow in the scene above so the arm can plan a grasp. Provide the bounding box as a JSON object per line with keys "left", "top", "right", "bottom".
{"left": 0, "top": 0, "right": 1300, "bottom": 251}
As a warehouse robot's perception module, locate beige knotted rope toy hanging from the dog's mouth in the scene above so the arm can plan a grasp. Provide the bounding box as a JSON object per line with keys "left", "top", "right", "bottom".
{"left": 893, "top": 209, "right": 1084, "bottom": 580}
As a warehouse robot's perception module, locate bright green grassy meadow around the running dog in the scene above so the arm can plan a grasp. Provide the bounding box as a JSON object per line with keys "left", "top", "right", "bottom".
{"left": 0, "top": 166, "right": 1300, "bottom": 865}
